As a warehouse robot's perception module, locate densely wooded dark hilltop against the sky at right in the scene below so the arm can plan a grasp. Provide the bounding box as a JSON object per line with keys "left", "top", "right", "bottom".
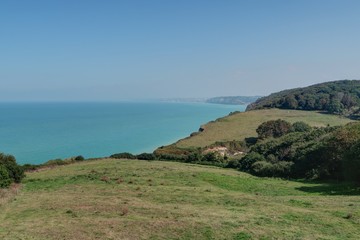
{"left": 247, "top": 80, "right": 360, "bottom": 115}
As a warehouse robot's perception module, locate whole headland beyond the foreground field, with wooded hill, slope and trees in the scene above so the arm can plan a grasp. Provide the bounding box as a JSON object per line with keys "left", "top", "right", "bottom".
{"left": 154, "top": 80, "right": 360, "bottom": 182}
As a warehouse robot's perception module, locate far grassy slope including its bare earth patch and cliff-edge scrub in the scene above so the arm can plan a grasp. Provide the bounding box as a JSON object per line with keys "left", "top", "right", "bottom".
{"left": 154, "top": 109, "right": 353, "bottom": 166}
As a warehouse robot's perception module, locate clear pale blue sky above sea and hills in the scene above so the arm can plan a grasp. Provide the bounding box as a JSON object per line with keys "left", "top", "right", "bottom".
{"left": 0, "top": 0, "right": 360, "bottom": 101}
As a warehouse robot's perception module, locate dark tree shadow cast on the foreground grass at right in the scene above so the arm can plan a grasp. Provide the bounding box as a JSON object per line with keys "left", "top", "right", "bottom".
{"left": 296, "top": 181, "right": 360, "bottom": 196}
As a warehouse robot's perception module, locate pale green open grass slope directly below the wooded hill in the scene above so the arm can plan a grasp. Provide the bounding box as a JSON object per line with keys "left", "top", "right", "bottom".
{"left": 175, "top": 109, "right": 351, "bottom": 148}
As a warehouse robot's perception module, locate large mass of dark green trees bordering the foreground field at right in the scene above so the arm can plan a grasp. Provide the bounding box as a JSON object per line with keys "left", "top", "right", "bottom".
{"left": 239, "top": 123, "right": 360, "bottom": 182}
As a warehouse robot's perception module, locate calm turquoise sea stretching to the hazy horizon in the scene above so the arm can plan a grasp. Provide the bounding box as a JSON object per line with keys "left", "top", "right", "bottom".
{"left": 0, "top": 102, "right": 245, "bottom": 164}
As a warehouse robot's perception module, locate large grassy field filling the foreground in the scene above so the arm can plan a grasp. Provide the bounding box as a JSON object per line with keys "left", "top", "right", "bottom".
{"left": 0, "top": 159, "right": 360, "bottom": 240}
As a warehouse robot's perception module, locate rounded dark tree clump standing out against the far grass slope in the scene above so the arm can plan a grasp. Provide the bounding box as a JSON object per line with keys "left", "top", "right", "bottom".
{"left": 256, "top": 119, "right": 291, "bottom": 139}
